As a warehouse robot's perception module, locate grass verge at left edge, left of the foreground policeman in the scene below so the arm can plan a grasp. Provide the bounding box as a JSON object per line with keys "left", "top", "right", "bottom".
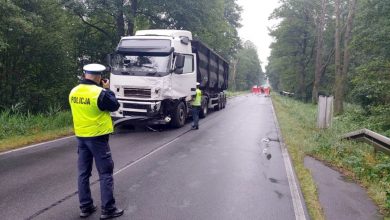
{"left": 0, "top": 111, "right": 73, "bottom": 152}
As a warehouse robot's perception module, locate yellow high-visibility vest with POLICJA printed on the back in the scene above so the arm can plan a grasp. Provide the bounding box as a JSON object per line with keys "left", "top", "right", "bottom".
{"left": 69, "top": 84, "right": 114, "bottom": 137}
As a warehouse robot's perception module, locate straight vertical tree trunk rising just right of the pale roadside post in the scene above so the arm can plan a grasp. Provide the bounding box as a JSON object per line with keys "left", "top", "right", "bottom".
{"left": 334, "top": 0, "right": 343, "bottom": 115}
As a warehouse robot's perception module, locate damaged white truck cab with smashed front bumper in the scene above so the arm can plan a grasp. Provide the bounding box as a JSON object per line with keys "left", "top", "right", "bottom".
{"left": 109, "top": 30, "right": 227, "bottom": 127}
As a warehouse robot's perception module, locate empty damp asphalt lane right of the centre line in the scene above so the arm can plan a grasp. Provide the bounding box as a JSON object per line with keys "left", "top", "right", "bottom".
{"left": 37, "top": 96, "right": 295, "bottom": 219}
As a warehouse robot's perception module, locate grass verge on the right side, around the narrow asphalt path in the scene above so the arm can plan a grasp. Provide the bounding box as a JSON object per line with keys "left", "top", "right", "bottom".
{"left": 272, "top": 94, "right": 390, "bottom": 219}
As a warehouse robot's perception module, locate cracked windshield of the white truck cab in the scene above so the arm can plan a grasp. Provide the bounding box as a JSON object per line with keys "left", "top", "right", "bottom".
{"left": 112, "top": 54, "right": 170, "bottom": 76}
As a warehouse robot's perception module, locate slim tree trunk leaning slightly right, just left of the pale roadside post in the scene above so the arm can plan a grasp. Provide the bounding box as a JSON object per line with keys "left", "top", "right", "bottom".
{"left": 312, "top": 0, "right": 326, "bottom": 104}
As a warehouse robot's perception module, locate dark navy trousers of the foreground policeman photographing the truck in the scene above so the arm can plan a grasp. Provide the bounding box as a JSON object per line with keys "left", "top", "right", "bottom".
{"left": 77, "top": 135, "right": 115, "bottom": 211}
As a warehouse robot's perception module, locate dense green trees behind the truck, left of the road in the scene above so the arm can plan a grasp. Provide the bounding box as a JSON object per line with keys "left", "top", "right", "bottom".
{"left": 0, "top": 0, "right": 260, "bottom": 112}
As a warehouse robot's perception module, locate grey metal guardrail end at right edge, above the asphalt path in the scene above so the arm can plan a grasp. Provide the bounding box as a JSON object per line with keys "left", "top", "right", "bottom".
{"left": 342, "top": 128, "right": 390, "bottom": 155}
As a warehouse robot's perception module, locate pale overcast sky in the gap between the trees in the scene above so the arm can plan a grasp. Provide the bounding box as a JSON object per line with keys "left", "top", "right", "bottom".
{"left": 237, "top": 0, "right": 279, "bottom": 71}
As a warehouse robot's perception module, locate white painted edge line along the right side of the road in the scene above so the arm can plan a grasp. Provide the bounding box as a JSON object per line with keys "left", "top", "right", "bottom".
{"left": 271, "top": 99, "right": 306, "bottom": 220}
